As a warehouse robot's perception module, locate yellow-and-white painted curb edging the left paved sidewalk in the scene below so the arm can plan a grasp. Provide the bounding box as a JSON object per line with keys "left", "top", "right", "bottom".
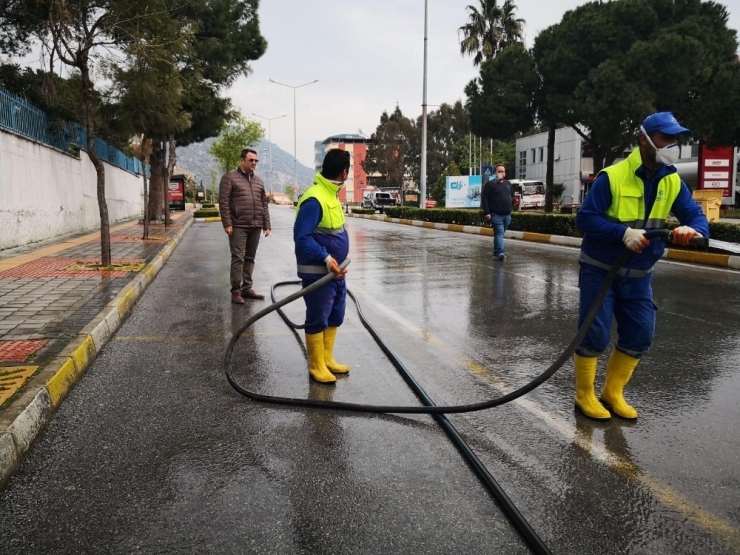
{"left": 0, "top": 219, "right": 193, "bottom": 487}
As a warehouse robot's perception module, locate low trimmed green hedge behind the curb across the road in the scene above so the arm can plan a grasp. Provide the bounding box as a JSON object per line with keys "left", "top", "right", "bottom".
{"left": 378, "top": 206, "right": 740, "bottom": 243}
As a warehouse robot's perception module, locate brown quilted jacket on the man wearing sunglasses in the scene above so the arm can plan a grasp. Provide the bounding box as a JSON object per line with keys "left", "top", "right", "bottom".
{"left": 218, "top": 169, "right": 271, "bottom": 229}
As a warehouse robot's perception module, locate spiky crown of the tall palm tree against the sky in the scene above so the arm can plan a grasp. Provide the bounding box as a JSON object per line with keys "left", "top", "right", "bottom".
{"left": 458, "top": 0, "right": 525, "bottom": 66}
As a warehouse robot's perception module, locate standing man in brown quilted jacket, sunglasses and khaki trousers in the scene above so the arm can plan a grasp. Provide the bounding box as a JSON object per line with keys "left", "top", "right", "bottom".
{"left": 218, "top": 148, "right": 270, "bottom": 304}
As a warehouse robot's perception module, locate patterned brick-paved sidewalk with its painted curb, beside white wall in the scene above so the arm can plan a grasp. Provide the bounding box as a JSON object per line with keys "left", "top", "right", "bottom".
{"left": 0, "top": 212, "right": 193, "bottom": 486}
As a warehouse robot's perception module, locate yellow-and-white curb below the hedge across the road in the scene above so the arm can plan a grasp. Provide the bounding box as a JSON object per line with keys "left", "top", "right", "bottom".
{"left": 347, "top": 214, "right": 740, "bottom": 270}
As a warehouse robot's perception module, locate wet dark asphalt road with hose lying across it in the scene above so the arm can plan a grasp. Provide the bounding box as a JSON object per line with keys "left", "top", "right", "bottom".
{"left": 0, "top": 207, "right": 740, "bottom": 554}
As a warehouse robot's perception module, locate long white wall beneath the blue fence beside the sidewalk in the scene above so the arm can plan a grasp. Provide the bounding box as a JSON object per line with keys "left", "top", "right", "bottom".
{"left": 0, "top": 130, "right": 144, "bottom": 250}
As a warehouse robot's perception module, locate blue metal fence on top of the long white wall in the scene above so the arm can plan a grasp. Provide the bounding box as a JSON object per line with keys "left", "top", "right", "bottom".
{"left": 0, "top": 88, "right": 141, "bottom": 174}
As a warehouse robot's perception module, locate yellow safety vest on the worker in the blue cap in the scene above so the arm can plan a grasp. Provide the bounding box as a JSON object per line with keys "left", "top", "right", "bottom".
{"left": 599, "top": 147, "right": 681, "bottom": 229}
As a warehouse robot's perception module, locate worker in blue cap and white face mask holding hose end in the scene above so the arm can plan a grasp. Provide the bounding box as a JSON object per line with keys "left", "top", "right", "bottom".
{"left": 574, "top": 112, "right": 709, "bottom": 420}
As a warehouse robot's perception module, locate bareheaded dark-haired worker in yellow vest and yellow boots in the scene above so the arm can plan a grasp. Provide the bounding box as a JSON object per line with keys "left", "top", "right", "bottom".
{"left": 293, "top": 149, "right": 350, "bottom": 383}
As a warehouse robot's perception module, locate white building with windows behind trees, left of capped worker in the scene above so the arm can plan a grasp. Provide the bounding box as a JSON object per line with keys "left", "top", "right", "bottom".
{"left": 509, "top": 127, "right": 582, "bottom": 203}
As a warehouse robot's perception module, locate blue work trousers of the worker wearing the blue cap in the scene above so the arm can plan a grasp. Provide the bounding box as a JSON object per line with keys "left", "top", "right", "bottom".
{"left": 576, "top": 263, "right": 658, "bottom": 358}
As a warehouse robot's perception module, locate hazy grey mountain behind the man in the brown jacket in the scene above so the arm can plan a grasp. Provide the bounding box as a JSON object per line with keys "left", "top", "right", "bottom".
{"left": 176, "top": 139, "right": 316, "bottom": 192}
